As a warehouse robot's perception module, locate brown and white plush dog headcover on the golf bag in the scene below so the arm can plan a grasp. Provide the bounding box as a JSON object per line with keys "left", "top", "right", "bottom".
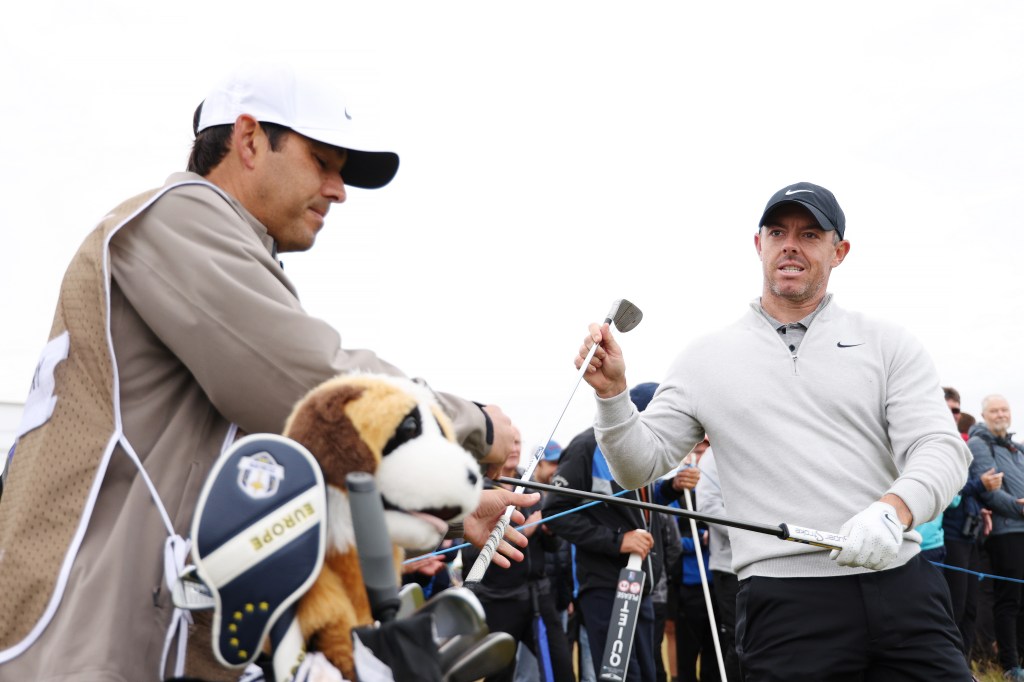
{"left": 285, "top": 375, "right": 482, "bottom": 679}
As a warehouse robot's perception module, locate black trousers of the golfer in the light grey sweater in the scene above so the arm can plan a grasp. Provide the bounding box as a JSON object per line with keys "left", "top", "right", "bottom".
{"left": 736, "top": 555, "right": 972, "bottom": 682}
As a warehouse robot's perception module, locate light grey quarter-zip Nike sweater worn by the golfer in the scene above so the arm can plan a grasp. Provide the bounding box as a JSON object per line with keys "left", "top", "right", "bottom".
{"left": 595, "top": 295, "right": 971, "bottom": 580}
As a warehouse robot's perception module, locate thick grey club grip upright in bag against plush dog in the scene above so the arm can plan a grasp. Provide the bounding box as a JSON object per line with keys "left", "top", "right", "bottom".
{"left": 345, "top": 471, "right": 401, "bottom": 623}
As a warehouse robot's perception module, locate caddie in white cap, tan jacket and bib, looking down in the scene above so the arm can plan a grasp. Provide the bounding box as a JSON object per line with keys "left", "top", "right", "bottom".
{"left": 0, "top": 65, "right": 539, "bottom": 682}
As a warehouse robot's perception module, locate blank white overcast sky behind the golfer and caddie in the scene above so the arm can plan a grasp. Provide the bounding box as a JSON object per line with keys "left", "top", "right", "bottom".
{"left": 0, "top": 0, "right": 1024, "bottom": 452}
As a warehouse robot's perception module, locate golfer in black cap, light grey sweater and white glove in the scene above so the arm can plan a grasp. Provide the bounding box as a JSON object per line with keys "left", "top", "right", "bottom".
{"left": 575, "top": 182, "right": 971, "bottom": 682}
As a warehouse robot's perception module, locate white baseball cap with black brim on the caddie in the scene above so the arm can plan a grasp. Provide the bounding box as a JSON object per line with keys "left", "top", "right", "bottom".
{"left": 194, "top": 65, "right": 398, "bottom": 189}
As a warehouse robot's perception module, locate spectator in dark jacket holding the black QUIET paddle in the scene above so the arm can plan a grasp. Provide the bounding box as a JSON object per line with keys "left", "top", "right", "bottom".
{"left": 543, "top": 383, "right": 666, "bottom": 682}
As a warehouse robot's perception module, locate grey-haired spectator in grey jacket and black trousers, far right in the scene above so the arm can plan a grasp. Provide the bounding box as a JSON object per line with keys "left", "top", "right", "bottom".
{"left": 968, "top": 394, "right": 1024, "bottom": 680}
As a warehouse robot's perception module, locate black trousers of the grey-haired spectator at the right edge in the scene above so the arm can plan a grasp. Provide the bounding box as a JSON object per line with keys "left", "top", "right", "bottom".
{"left": 985, "top": 532, "right": 1024, "bottom": 670}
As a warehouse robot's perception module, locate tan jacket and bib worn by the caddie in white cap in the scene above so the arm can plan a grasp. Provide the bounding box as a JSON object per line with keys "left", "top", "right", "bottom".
{"left": 0, "top": 173, "right": 489, "bottom": 682}
